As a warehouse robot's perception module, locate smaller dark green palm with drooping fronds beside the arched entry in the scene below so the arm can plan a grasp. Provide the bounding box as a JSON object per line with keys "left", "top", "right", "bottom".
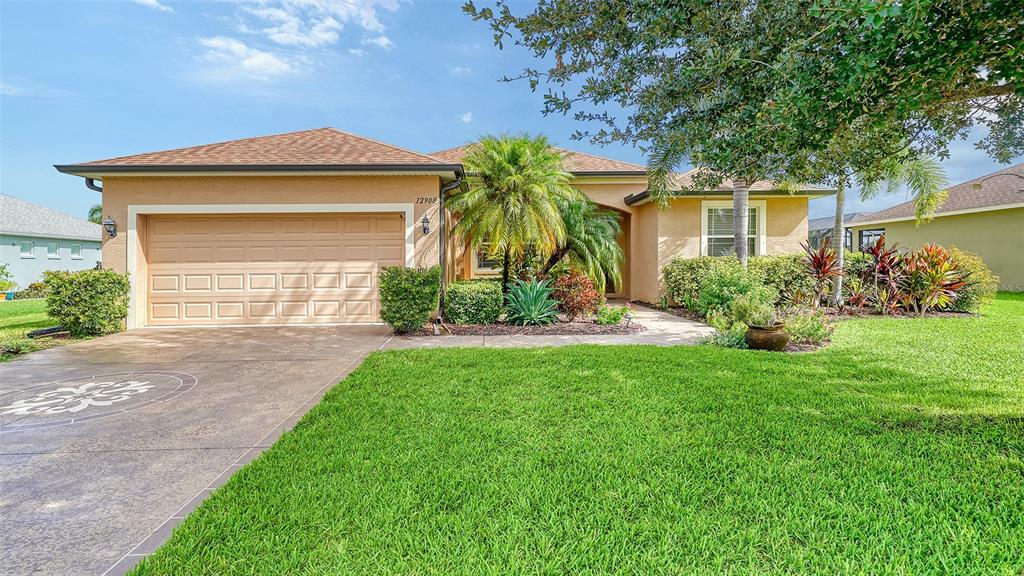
{"left": 543, "top": 198, "right": 626, "bottom": 292}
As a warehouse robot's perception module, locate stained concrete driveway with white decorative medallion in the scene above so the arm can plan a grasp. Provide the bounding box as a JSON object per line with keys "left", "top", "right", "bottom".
{"left": 0, "top": 326, "right": 389, "bottom": 575}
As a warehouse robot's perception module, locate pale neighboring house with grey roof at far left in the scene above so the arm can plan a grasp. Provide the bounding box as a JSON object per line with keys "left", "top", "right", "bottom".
{"left": 0, "top": 195, "right": 101, "bottom": 288}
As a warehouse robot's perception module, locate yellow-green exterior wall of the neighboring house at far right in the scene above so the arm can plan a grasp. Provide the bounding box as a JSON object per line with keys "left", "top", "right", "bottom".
{"left": 851, "top": 208, "right": 1024, "bottom": 292}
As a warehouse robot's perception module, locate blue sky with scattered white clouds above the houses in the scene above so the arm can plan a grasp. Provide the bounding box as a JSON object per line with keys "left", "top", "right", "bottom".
{"left": 0, "top": 0, "right": 1020, "bottom": 222}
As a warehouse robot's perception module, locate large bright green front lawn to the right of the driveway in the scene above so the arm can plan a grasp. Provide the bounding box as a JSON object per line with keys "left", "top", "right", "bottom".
{"left": 136, "top": 294, "right": 1024, "bottom": 575}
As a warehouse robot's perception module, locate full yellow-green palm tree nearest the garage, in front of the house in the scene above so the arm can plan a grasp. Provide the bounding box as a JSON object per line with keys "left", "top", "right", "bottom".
{"left": 449, "top": 134, "right": 581, "bottom": 290}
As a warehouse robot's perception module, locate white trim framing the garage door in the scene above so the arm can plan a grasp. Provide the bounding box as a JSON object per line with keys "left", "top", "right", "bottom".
{"left": 125, "top": 202, "right": 416, "bottom": 329}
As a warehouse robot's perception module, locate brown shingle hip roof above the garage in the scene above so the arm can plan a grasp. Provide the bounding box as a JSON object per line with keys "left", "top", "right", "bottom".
{"left": 68, "top": 128, "right": 444, "bottom": 167}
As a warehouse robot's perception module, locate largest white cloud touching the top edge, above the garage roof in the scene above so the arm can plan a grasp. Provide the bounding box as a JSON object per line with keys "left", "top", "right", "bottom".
{"left": 237, "top": 0, "right": 399, "bottom": 48}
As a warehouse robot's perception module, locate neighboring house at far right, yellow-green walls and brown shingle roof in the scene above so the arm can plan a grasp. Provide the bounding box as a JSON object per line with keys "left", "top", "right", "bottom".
{"left": 850, "top": 163, "right": 1024, "bottom": 292}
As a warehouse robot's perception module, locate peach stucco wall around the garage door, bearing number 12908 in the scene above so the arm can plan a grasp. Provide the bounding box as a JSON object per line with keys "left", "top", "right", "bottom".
{"left": 97, "top": 175, "right": 440, "bottom": 319}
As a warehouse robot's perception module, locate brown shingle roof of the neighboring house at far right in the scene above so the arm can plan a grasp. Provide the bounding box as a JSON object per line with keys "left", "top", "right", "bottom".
{"left": 852, "top": 163, "right": 1024, "bottom": 223}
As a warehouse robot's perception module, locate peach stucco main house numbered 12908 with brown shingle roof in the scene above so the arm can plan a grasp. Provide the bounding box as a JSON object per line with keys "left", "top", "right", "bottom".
{"left": 56, "top": 128, "right": 831, "bottom": 328}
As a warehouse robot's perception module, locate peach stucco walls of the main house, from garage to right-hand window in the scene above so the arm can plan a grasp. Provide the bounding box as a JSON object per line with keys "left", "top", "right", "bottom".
{"left": 103, "top": 175, "right": 807, "bottom": 311}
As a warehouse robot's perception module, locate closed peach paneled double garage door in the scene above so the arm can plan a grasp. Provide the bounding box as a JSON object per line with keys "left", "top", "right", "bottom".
{"left": 144, "top": 213, "right": 406, "bottom": 326}
